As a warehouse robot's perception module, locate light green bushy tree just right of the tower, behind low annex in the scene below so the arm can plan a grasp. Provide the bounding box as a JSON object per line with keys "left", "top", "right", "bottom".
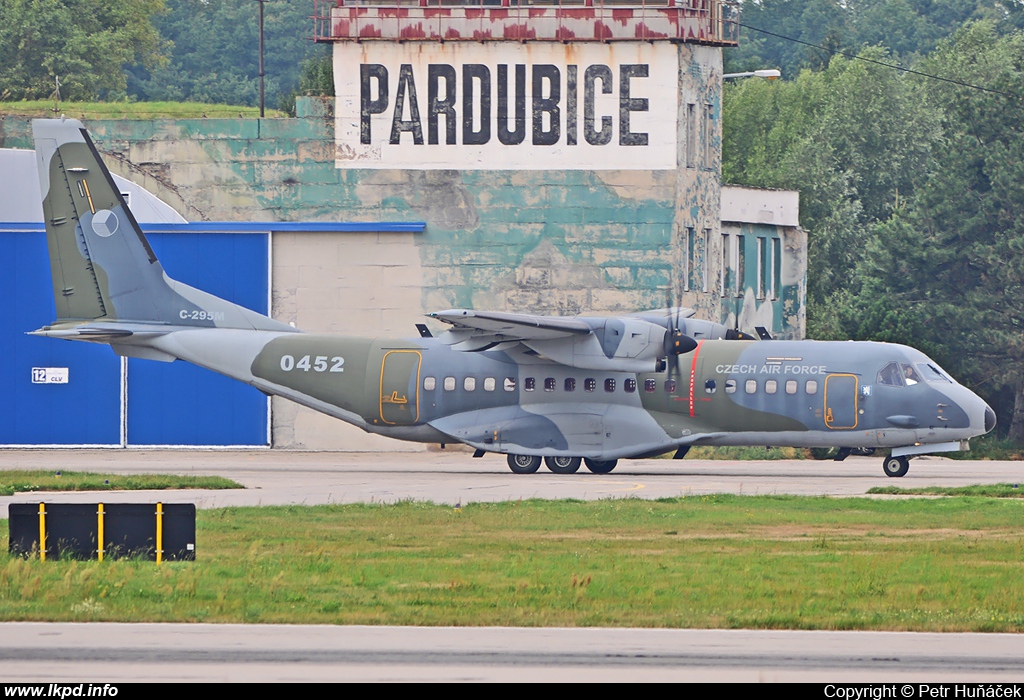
{"left": 723, "top": 47, "right": 940, "bottom": 339}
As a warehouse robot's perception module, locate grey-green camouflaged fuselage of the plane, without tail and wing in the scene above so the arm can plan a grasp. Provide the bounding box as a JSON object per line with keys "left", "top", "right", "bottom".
{"left": 175, "top": 334, "right": 986, "bottom": 460}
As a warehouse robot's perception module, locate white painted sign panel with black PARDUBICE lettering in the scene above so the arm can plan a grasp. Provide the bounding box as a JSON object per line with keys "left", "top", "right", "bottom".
{"left": 335, "top": 42, "right": 678, "bottom": 170}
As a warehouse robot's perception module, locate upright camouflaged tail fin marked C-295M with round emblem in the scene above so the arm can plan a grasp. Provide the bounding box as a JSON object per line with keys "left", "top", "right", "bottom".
{"left": 32, "top": 119, "right": 293, "bottom": 335}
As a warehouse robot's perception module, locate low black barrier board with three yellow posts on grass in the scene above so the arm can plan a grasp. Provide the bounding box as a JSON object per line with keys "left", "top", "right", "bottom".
{"left": 8, "top": 502, "right": 196, "bottom": 564}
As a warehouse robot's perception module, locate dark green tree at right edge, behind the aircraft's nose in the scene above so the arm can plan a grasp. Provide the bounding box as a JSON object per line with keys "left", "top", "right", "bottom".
{"left": 851, "top": 21, "right": 1024, "bottom": 441}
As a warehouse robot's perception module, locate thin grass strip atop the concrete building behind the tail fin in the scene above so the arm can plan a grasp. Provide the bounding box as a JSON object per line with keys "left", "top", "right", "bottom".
{"left": 0, "top": 99, "right": 287, "bottom": 119}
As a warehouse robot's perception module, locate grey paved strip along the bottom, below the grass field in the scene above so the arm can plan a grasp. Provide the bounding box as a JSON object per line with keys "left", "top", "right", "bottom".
{"left": 6, "top": 622, "right": 1024, "bottom": 679}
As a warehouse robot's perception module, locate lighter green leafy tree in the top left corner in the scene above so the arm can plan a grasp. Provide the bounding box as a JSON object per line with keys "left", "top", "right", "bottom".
{"left": 0, "top": 0, "right": 164, "bottom": 100}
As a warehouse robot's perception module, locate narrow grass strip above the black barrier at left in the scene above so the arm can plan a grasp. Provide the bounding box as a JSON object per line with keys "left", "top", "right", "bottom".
{"left": 0, "top": 470, "right": 243, "bottom": 495}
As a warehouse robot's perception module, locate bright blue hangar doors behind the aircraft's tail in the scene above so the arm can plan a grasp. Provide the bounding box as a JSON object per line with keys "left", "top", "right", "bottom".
{"left": 0, "top": 225, "right": 269, "bottom": 445}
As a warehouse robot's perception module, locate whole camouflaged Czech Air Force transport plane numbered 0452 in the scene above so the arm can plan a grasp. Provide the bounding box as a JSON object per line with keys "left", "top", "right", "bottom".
{"left": 33, "top": 119, "right": 995, "bottom": 477}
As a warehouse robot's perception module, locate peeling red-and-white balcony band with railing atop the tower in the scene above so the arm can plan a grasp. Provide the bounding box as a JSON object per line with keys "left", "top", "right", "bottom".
{"left": 313, "top": 0, "right": 739, "bottom": 46}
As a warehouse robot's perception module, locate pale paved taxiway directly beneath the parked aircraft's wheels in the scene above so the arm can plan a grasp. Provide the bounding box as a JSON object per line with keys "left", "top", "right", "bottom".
{"left": 0, "top": 449, "right": 1024, "bottom": 518}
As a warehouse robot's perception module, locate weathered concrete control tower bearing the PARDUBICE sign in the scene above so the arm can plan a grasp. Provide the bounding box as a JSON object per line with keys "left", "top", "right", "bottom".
{"left": 315, "top": 0, "right": 740, "bottom": 318}
